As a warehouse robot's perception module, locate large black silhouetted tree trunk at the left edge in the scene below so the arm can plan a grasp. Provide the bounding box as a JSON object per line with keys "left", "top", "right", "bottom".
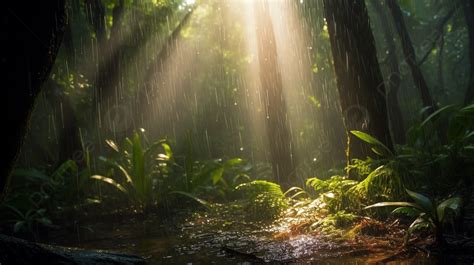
{"left": 0, "top": 0, "right": 66, "bottom": 200}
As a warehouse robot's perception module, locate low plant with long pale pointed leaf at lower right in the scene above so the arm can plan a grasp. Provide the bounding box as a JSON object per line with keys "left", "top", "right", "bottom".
{"left": 364, "top": 189, "right": 461, "bottom": 245}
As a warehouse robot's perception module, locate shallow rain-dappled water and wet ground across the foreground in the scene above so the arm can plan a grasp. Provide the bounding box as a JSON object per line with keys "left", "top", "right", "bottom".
{"left": 48, "top": 203, "right": 474, "bottom": 264}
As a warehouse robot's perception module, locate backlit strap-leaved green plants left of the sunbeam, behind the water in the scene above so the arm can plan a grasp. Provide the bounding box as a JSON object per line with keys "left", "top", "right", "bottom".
{"left": 91, "top": 130, "right": 248, "bottom": 208}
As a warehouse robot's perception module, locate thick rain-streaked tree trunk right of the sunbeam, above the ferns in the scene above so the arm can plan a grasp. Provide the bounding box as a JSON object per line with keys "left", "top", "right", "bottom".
{"left": 324, "top": 0, "right": 393, "bottom": 162}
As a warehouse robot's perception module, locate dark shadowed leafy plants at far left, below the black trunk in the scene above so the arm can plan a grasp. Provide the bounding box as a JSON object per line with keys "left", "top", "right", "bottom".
{"left": 0, "top": 160, "right": 88, "bottom": 237}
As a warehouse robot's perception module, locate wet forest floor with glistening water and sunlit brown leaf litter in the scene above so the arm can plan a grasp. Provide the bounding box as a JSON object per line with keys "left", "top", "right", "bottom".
{"left": 39, "top": 201, "right": 474, "bottom": 264}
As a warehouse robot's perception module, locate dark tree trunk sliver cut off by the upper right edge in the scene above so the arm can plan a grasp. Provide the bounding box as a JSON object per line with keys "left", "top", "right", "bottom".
{"left": 464, "top": 0, "right": 474, "bottom": 105}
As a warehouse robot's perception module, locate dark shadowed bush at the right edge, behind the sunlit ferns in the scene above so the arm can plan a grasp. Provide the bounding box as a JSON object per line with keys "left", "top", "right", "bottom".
{"left": 399, "top": 104, "right": 474, "bottom": 195}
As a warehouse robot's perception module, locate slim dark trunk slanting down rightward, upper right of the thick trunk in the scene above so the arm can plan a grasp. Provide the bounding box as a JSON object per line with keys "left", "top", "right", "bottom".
{"left": 386, "top": 0, "right": 436, "bottom": 113}
